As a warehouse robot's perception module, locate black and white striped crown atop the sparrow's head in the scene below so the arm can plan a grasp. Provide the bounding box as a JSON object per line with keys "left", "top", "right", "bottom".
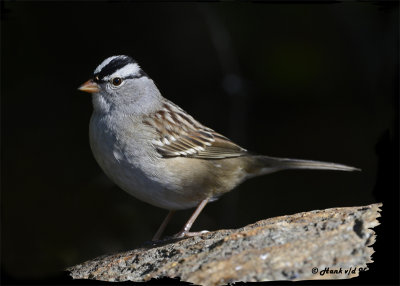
{"left": 94, "top": 55, "right": 147, "bottom": 82}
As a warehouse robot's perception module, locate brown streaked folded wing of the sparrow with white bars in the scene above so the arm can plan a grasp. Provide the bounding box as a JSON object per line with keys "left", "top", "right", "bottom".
{"left": 143, "top": 102, "right": 247, "bottom": 159}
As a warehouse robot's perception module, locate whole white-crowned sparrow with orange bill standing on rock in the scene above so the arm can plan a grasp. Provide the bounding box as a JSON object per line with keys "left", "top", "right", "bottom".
{"left": 79, "top": 55, "right": 357, "bottom": 240}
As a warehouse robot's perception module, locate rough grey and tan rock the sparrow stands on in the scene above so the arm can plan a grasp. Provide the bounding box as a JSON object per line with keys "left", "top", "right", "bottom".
{"left": 67, "top": 204, "right": 382, "bottom": 285}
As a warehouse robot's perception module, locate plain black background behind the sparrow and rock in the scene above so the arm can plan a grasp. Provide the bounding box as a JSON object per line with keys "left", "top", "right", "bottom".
{"left": 1, "top": 2, "right": 399, "bottom": 284}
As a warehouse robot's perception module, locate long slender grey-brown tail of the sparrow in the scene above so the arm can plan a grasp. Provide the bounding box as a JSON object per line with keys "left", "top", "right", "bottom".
{"left": 251, "top": 156, "right": 361, "bottom": 176}
